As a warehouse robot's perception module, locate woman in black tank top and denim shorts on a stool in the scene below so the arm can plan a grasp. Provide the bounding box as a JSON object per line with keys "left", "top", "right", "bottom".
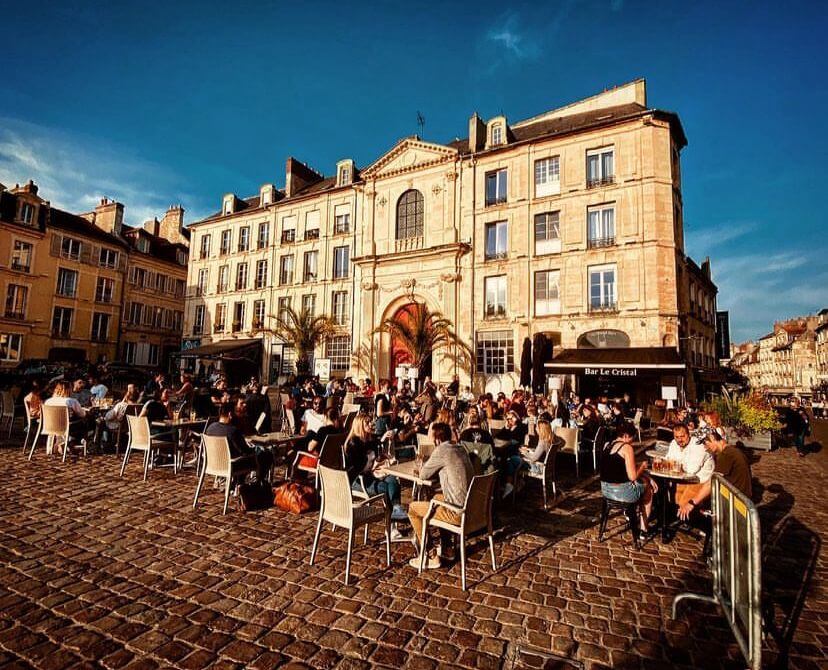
{"left": 600, "top": 423, "right": 657, "bottom": 533}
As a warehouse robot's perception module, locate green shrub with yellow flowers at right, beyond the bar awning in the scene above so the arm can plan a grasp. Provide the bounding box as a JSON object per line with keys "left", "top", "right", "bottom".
{"left": 704, "top": 388, "right": 782, "bottom": 451}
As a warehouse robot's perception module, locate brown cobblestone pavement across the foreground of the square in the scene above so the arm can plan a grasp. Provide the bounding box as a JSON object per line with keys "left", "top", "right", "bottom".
{"left": 0, "top": 425, "right": 828, "bottom": 668}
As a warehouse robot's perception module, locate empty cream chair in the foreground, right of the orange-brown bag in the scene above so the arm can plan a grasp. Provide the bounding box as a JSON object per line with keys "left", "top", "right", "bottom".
{"left": 310, "top": 464, "right": 391, "bottom": 586}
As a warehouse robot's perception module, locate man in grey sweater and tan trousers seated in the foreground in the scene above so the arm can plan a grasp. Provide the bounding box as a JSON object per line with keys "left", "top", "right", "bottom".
{"left": 408, "top": 423, "right": 474, "bottom": 570}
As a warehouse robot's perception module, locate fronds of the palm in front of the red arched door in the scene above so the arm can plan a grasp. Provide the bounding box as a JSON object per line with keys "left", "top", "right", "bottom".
{"left": 374, "top": 303, "right": 471, "bottom": 378}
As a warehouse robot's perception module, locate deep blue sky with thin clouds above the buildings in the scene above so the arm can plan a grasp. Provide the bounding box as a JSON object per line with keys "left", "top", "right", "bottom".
{"left": 0, "top": 0, "right": 828, "bottom": 339}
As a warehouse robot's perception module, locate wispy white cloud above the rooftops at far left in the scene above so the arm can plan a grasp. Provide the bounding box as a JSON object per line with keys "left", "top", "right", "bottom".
{"left": 0, "top": 118, "right": 209, "bottom": 225}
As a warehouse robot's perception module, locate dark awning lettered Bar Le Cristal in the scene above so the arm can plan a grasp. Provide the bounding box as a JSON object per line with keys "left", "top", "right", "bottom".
{"left": 546, "top": 347, "right": 686, "bottom": 377}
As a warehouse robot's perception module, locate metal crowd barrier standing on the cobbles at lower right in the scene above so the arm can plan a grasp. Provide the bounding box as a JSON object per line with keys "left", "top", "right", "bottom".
{"left": 673, "top": 474, "right": 762, "bottom": 670}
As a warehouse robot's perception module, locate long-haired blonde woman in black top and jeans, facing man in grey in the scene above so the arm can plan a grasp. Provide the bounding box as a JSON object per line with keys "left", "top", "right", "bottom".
{"left": 345, "top": 414, "right": 408, "bottom": 537}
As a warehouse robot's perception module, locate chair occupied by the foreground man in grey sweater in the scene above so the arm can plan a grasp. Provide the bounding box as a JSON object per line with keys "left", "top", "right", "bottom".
{"left": 418, "top": 472, "right": 498, "bottom": 591}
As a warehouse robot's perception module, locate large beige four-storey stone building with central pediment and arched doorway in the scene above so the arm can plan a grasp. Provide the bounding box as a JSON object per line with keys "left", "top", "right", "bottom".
{"left": 185, "top": 81, "right": 716, "bottom": 404}
